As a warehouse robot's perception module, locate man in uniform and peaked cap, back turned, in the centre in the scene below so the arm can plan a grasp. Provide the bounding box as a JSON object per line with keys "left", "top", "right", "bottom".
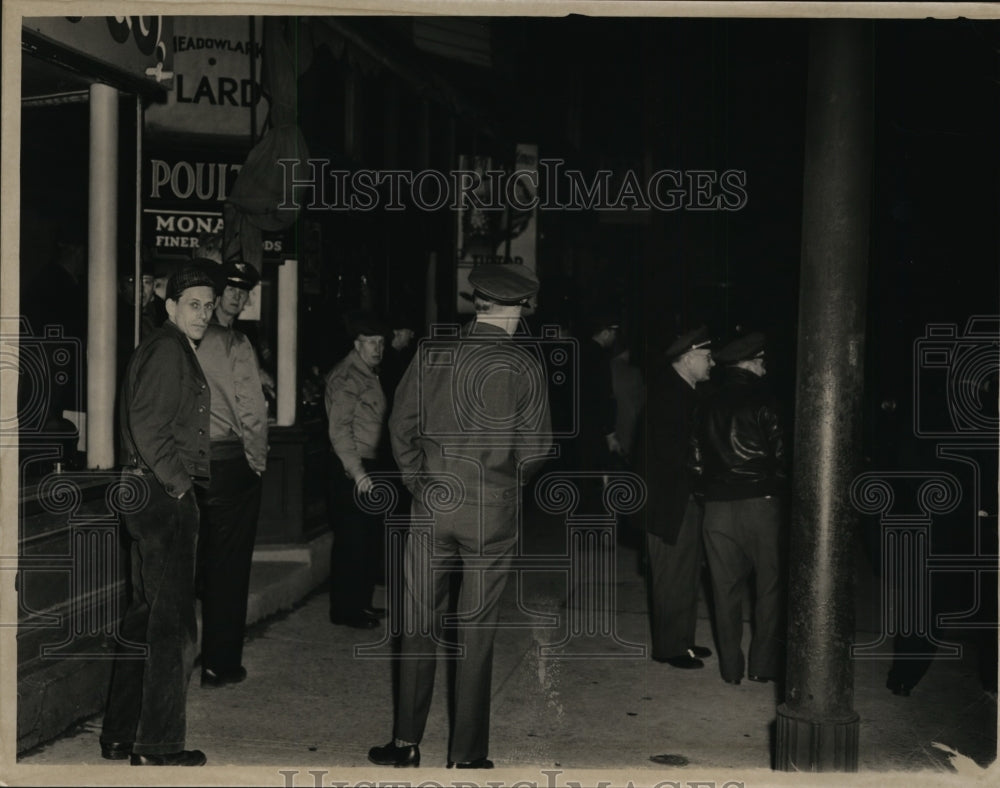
{"left": 368, "top": 265, "right": 552, "bottom": 769}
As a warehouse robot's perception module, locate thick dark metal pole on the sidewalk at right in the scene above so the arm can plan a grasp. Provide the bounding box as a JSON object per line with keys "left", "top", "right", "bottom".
{"left": 776, "top": 21, "right": 872, "bottom": 772}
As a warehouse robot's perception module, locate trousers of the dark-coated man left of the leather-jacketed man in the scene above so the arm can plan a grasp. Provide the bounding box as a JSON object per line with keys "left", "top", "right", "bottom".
{"left": 646, "top": 498, "right": 702, "bottom": 660}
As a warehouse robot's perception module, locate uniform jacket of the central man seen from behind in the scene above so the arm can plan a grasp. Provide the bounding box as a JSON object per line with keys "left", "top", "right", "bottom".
{"left": 389, "top": 321, "right": 552, "bottom": 506}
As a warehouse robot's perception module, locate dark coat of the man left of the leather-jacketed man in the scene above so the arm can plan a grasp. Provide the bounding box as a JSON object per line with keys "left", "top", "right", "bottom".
{"left": 644, "top": 364, "right": 700, "bottom": 544}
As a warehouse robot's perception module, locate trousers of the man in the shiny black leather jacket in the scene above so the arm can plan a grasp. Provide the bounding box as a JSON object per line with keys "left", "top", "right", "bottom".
{"left": 705, "top": 497, "right": 782, "bottom": 681}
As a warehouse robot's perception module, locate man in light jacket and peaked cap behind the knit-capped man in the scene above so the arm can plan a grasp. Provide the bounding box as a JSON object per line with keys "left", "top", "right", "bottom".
{"left": 194, "top": 259, "right": 267, "bottom": 687}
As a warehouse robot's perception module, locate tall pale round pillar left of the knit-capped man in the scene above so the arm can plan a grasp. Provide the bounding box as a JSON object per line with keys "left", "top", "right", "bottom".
{"left": 87, "top": 83, "right": 118, "bottom": 468}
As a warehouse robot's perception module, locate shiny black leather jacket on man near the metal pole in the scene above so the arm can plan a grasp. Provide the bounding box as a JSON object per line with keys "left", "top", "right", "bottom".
{"left": 692, "top": 367, "right": 786, "bottom": 500}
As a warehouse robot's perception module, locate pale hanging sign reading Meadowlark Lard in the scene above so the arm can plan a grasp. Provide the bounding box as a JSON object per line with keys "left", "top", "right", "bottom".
{"left": 146, "top": 16, "right": 268, "bottom": 137}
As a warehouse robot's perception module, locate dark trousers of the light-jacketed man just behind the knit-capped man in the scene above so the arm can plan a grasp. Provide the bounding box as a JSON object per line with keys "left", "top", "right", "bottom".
{"left": 197, "top": 457, "right": 261, "bottom": 670}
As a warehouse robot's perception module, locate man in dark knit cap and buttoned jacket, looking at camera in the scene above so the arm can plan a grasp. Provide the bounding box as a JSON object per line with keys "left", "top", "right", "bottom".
{"left": 101, "top": 264, "right": 215, "bottom": 766}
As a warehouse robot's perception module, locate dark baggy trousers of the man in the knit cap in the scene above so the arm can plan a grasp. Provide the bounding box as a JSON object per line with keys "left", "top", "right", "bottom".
{"left": 101, "top": 484, "right": 198, "bottom": 754}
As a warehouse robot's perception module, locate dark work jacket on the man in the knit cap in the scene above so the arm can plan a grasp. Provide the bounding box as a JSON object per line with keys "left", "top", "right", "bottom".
{"left": 120, "top": 320, "right": 211, "bottom": 497}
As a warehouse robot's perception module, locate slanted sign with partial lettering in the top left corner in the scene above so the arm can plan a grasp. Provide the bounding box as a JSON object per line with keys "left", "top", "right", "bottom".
{"left": 22, "top": 16, "right": 174, "bottom": 86}
